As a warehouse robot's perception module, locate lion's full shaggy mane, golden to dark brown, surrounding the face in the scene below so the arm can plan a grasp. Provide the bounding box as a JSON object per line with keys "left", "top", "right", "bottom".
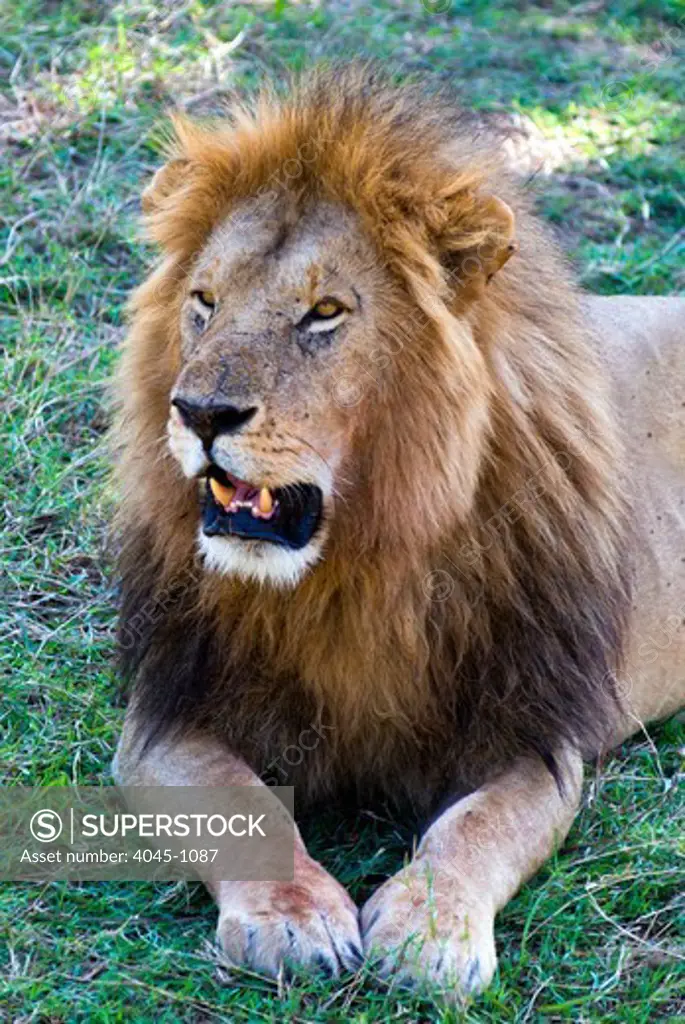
{"left": 113, "top": 68, "right": 630, "bottom": 807}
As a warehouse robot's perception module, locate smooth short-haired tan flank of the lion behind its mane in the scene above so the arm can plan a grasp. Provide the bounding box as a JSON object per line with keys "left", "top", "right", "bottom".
{"left": 584, "top": 297, "right": 685, "bottom": 745}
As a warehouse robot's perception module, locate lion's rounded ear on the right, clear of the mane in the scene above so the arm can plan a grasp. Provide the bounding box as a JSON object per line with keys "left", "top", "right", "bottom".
{"left": 442, "top": 196, "right": 518, "bottom": 302}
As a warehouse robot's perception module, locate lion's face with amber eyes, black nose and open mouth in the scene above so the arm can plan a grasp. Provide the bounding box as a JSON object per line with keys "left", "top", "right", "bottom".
{"left": 168, "top": 193, "right": 392, "bottom": 585}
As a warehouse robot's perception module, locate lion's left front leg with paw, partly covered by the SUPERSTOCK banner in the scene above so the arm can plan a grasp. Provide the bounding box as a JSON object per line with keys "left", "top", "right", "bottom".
{"left": 114, "top": 713, "right": 362, "bottom": 975}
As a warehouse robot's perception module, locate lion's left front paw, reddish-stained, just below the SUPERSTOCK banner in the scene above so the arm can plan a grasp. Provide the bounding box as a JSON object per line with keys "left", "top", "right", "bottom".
{"left": 217, "top": 860, "right": 362, "bottom": 977}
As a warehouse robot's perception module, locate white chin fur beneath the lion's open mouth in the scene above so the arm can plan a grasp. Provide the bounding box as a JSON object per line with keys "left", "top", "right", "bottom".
{"left": 198, "top": 527, "right": 324, "bottom": 587}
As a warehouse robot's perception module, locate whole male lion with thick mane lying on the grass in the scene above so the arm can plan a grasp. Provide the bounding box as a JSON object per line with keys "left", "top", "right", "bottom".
{"left": 116, "top": 69, "right": 685, "bottom": 991}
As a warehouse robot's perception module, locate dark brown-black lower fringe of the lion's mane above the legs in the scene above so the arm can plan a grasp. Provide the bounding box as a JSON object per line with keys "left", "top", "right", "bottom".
{"left": 120, "top": 507, "right": 629, "bottom": 815}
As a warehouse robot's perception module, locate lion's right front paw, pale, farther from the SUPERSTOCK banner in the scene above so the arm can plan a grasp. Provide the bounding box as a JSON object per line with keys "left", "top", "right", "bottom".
{"left": 361, "top": 858, "right": 497, "bottom": 998}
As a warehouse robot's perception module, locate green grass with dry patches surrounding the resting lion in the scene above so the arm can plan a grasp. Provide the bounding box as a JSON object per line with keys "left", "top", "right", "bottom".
{"left": 0, "top": 0, "right": 685, "bottom": 1024}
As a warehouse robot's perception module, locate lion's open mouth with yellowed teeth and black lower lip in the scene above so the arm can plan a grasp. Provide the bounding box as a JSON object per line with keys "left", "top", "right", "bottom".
{"left": 202, "top": 464, "right": 324, "bottom": 550}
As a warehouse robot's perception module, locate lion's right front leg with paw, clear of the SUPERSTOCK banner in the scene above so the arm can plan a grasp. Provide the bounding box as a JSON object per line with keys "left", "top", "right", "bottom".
{"left": 361, "top": 754, "right": 583, "bottom": 995}
